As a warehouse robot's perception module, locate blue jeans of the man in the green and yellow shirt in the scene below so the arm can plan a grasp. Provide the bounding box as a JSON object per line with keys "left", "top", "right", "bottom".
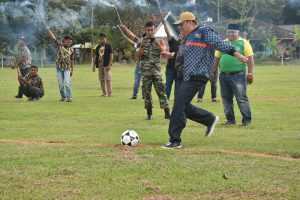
{"left": 220, "top": 71, "right": 251, "bottom": 123}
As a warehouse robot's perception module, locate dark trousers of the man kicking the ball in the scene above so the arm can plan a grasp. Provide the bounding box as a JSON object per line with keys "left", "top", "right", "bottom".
{"left": 169, "top": 81, "right": 215, "bottom": 143}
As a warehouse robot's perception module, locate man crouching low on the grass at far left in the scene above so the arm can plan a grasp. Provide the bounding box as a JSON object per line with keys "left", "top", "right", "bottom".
{"left": 18, "top": 65, "right": 44, "bottom": 101}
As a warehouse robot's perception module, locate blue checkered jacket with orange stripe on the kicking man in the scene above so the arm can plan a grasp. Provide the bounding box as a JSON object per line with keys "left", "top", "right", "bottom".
{"left": 183, "top": 26, "right": 235, "bottom": 81}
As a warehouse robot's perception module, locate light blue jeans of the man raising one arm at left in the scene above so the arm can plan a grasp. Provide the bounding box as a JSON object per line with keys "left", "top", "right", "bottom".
{"left": 56, "top": 68, "right": 72, "bottom": 100}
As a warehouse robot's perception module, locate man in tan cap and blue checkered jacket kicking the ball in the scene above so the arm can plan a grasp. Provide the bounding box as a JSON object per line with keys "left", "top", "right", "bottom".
{"left": 162, "top": 12, "right": 247, "bottom": 149}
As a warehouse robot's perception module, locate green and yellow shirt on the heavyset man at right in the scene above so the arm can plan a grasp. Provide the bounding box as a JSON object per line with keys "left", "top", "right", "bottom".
{"left": 215, "top": 37, "right": 253, "bottom": 73}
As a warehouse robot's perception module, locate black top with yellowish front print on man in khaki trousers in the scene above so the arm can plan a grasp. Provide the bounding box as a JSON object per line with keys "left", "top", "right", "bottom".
{"left": 96, "top": 44, "right": 113, "bottom": 67}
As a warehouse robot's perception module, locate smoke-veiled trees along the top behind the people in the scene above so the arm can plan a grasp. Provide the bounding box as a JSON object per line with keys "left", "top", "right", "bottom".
{"left": 0, "top": 0, "right": 300, "bottom": 61}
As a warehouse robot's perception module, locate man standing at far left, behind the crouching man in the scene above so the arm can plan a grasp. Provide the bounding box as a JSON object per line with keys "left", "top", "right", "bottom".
{"left": 15, "top": 37, "right": 31, "bottom": 98}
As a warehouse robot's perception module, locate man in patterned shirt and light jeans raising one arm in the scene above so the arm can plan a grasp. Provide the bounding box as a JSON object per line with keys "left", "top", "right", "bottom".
{"left": 46, "top": 26, "right": 74, "bottom": 102}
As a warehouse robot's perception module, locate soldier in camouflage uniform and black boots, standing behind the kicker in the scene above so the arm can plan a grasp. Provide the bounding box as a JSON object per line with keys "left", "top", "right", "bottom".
{"left": 136, "top": 22, "right": 170, "bottom": 120}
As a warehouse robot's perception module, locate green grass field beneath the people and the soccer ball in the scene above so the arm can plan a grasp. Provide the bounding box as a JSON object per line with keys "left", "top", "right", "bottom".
{"left": 0, "top": 65, "right": 300, "bottom": 200}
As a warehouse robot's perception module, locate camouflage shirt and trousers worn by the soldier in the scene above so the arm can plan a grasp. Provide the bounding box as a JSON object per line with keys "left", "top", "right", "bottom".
{"left": 140, "top": 39, "right": 169, "bottom": 109}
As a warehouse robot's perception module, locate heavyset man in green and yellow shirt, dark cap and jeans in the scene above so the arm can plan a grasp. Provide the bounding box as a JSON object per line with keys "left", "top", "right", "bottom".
{"left": 214, "top": 24, "right": 254, "bottom": 126}
